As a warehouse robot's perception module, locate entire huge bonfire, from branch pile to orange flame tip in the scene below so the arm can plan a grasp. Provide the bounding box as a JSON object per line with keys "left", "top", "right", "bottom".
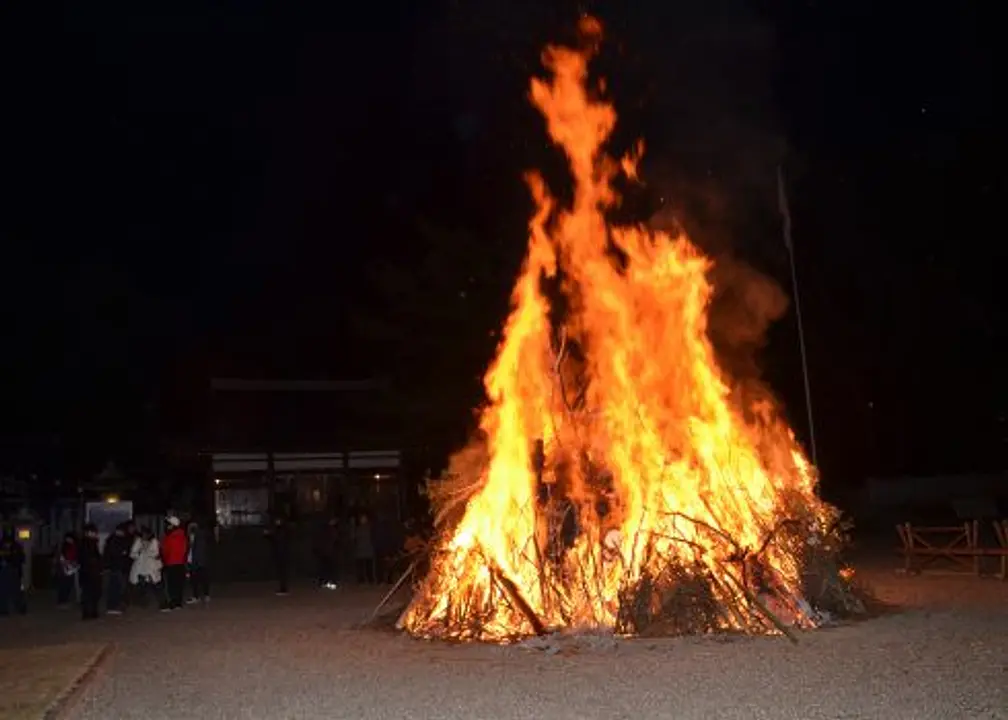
{"left": 398, "top": 19, "right": 858, "bottom": 641}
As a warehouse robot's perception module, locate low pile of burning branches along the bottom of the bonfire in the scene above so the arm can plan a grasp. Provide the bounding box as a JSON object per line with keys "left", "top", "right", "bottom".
{"left": 399, "top": 480, "right": 868, "bottom": 641}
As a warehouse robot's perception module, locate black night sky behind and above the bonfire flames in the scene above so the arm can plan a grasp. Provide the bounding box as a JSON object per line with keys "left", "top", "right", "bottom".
{"left": 0, "top": 0, "right": 1008, "bottom": 488}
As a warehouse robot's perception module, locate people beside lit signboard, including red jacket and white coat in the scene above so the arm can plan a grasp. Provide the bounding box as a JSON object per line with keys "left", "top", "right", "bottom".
{"left": 53, "top": 515, "right": 210, "bottom": 620}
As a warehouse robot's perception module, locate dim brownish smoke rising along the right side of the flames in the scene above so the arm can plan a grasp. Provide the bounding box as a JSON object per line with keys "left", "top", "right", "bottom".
{"left": 603, "top": 0, "right": 789, "bottom": 387}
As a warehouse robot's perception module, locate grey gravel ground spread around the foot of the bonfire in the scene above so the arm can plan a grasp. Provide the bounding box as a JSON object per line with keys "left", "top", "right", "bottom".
{"left": 7, "top": 571, "right": 1008, "bottom": 720}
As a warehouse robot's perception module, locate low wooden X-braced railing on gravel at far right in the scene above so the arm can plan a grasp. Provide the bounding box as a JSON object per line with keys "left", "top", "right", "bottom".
{"left": 896, "top": 520, "right": 1008, "bottom": 580}
